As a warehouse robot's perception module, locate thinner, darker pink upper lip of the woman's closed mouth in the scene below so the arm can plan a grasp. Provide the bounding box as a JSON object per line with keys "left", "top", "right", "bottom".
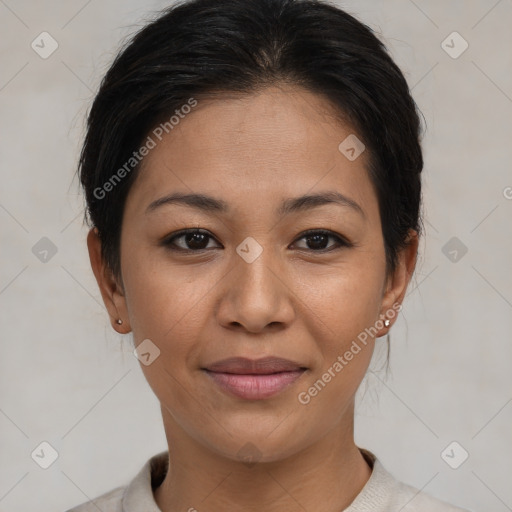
{"left": 204, "top": 357, "right": 305, "bottom": 375}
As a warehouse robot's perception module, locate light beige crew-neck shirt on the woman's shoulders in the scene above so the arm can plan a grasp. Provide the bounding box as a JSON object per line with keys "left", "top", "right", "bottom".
{"left": 66, "top": 449, "right": 469, "bottom": 512}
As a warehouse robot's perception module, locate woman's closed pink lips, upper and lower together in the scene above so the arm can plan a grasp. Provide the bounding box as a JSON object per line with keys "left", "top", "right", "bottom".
{"left": 204, "top": 357, "right": 305, "bottom": 400}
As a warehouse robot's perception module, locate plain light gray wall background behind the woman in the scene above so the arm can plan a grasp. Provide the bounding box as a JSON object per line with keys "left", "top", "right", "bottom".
{"left": 0, "top": 0, "right": 512, "bottom": 512}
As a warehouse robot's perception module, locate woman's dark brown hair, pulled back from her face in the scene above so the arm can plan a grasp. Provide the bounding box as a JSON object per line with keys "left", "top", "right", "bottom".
{"left": 79, "top": 0, "right": 423, "bottom": 276}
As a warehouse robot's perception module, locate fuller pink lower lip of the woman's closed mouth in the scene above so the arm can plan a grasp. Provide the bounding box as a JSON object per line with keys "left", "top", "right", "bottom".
{"left": 206, "top": 370, "right": 305, "bottom": 400}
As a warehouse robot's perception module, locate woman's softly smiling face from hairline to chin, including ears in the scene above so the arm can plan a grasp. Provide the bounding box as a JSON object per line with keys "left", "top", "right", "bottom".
{"left": 90, "top": 88, "right": 417, "bottom": 461}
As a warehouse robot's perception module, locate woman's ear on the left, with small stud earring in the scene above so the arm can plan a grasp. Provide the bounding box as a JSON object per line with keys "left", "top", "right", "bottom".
{"left": 87, "top": 228, "right": 131, "bottom": 334}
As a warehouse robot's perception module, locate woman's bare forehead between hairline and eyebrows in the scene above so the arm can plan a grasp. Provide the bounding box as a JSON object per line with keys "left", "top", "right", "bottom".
{"left": 126, "top": 87, "right": 376, "bottom": 224}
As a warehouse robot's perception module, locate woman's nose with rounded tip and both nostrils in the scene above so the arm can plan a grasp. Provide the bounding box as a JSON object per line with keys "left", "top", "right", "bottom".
{"left": 217, "top": 243, "right": 295, "bottom": 333}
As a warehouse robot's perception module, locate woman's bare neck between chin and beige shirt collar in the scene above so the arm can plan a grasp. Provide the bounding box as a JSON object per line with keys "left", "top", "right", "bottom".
{"left": 154, "top": 409, "right": 371, "bottom": 512}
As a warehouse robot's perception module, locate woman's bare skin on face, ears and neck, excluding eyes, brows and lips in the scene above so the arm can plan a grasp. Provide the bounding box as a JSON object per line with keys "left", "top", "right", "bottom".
{"left": 88, "top": 86, "right": 418, "bottom": 512}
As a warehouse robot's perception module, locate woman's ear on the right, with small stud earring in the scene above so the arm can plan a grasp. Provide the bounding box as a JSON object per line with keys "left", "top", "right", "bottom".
{"left": 377, "top": 229, "right": 419, "bottom": 337}
